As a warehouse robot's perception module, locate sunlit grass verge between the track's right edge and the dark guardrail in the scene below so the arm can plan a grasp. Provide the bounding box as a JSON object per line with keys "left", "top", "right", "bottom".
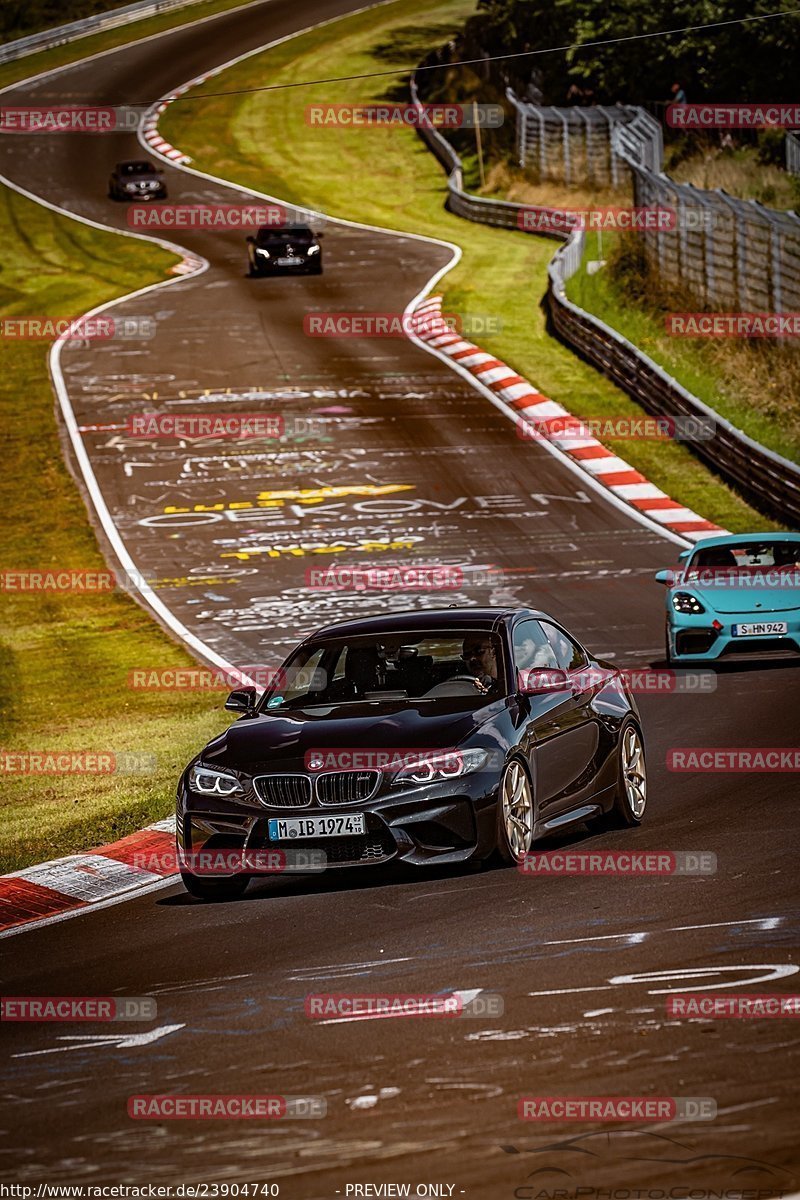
{"left": 162, "top": 0, "right": 770, "bottom": 530}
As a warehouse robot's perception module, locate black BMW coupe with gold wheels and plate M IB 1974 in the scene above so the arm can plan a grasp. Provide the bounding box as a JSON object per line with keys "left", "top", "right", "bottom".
{"left": 178, "top": 607, "right": 646, "bottom": 899}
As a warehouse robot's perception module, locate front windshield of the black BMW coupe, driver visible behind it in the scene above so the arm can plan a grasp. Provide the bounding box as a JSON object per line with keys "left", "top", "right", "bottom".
{"left": 261, "top": 630, "right": 505, "bottom": 712}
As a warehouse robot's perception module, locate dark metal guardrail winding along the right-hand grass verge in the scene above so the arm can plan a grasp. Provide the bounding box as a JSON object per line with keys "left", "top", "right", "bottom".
{"left": 410, "top": 69, "right": 800, "bottom": 527}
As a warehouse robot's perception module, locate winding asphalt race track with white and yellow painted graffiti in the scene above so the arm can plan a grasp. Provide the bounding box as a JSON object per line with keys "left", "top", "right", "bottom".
{"left": 0, "top": 0, "right": 800, "bottom": 1200}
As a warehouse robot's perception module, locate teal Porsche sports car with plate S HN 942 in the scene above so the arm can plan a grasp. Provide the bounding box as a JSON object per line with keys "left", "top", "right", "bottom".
{"left": 656, "top": 533, "right": 800, "bottom": 664}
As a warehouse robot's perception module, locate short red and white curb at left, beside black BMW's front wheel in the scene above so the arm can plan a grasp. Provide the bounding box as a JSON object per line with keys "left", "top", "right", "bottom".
{"left": 0, "top": 817, "right": 175, "bottom": 936}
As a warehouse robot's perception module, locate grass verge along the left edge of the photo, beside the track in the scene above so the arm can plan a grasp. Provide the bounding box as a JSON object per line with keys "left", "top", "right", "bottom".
{"left": 0, "top": 188, "right": 231, "bottom": 871}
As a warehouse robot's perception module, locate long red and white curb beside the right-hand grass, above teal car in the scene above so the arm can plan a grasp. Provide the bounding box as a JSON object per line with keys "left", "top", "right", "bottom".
{"left": 411, "top": 296, "right": 728, "bottom": 541}
